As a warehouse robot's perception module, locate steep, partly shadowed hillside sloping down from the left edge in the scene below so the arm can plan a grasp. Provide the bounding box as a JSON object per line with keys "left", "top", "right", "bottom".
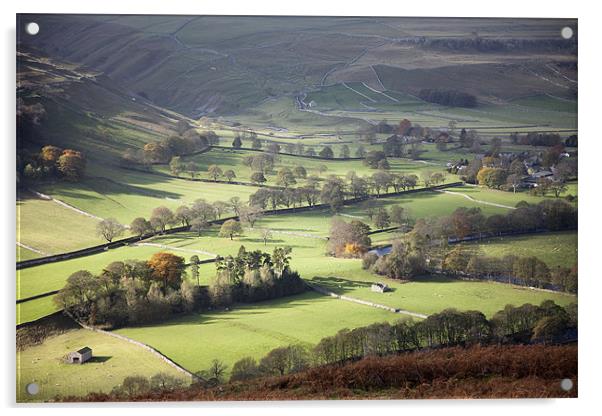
{"left": 17, "top": 45, "right": 182, "bottom": 161}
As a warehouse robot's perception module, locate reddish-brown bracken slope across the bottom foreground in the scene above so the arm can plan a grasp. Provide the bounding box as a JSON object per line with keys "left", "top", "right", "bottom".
{"left": 67, "top": 345, "right": 577, "bottom": 401}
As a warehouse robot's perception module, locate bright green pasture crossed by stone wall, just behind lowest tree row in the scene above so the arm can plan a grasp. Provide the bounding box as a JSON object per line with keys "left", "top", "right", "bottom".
{"left": 117, "top": 280, "right": 575, "bottom": 380}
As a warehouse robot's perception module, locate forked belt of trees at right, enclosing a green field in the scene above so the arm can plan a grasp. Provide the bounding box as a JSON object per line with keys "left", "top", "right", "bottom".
{"left": 356, "top": 200, "right": 577, "bottom": 284}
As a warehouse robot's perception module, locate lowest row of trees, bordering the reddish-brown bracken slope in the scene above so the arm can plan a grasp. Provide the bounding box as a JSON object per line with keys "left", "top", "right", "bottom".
{"left": 230, "top": 301, "right": 577, "bottom": 382}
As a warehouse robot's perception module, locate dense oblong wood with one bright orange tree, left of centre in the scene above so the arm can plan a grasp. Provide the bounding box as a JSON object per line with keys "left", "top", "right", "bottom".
{"left": 54, "top": 246, "right": 306, "bottom": 328}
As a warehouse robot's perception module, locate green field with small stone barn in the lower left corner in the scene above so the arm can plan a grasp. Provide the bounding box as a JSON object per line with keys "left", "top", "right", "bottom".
{"left": 17, "top": 329, "right": 190, "bottom": 402}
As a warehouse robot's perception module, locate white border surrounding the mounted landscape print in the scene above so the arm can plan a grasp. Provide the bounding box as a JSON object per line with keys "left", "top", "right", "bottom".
{"left": 0, "top": 0, "right": 602, "bottom": 416}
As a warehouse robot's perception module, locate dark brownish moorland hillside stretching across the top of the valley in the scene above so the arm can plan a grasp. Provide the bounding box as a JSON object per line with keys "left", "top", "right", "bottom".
{"left": 20, "top": 15, "right": 577, "bottom": 117}
